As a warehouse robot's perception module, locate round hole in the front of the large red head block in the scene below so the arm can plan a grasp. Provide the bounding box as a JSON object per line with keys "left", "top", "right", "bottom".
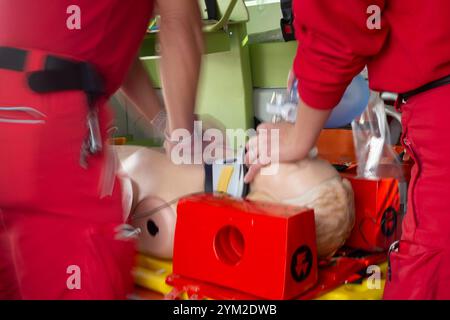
{"left": 214, "top": 226, "right": 245, "bottom": 266}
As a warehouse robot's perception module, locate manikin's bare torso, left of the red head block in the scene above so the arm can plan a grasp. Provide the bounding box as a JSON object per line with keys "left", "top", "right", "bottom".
{"left": 115, "top": 146, "right": 203, "bottom": 259}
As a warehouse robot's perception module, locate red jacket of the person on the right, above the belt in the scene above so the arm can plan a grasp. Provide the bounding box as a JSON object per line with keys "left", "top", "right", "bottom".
{"left": 293, "top": 0, "right": 450, "bottom": 109}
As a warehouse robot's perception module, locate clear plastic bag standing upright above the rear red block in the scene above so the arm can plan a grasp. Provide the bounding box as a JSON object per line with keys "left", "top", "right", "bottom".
{"left": 352, "top": 92, "right": 404, "bottom": 181}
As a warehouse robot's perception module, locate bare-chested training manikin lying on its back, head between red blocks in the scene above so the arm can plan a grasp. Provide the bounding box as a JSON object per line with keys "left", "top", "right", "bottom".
{"left": 114, "top": 146, "right": 354, "bottom": 259}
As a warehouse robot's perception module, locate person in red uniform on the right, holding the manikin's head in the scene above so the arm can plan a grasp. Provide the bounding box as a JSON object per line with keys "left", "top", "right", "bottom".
{"left": 247, "top": 0, "right": 450, "bottom": 299}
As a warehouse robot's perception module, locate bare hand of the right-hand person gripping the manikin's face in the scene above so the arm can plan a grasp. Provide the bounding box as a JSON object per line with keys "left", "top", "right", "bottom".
{"left": 244, "top": 122, "right": 308, "bottom": 183}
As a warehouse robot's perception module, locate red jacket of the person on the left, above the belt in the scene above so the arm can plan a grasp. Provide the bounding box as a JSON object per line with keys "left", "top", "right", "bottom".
{"left": 0, "top": 0, "right": 154, "bottom": 94}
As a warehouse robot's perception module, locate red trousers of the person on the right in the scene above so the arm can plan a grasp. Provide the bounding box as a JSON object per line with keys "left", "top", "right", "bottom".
{"left": 384, "top": 85, "right": 450, "bottom": 299}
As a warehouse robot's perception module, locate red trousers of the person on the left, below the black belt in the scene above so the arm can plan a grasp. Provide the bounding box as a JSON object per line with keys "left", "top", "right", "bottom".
{"left": 0, "top": 52, "right": 134, "bottom": 299}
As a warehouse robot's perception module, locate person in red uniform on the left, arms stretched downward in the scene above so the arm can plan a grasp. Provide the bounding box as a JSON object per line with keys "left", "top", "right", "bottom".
{"left": 0, "top": 0, "right": 202, "bottom": 299}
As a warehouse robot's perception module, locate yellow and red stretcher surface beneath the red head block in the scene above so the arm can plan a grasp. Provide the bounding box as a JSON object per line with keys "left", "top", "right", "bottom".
{"left": 134, "top": 251, "right": 387, "bottom": 300}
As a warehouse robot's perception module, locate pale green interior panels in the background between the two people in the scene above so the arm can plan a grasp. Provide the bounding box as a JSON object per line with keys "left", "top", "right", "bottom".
{"left": 134, "top": 3, "right": 296, "bottom": 139}
